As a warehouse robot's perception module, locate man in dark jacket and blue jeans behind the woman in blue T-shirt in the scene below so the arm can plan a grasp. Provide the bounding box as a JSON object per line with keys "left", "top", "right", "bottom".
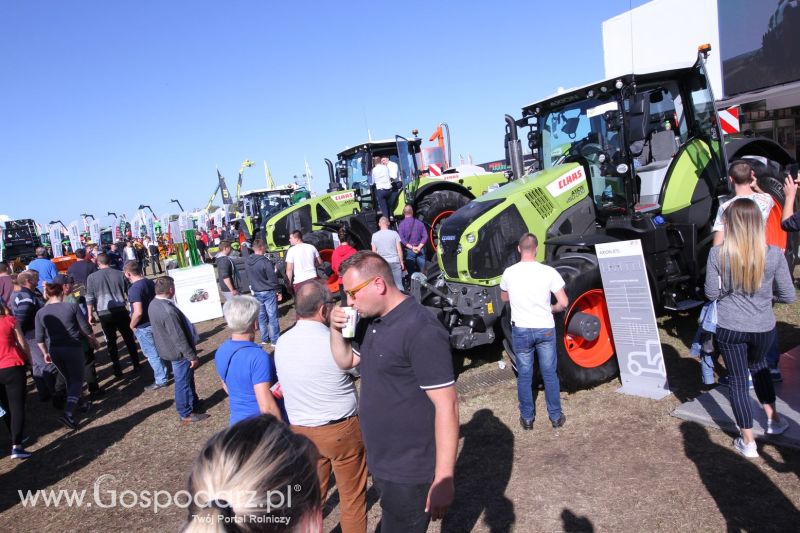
{"left": 244, "top": 239, "right": 283, "bottom": 346}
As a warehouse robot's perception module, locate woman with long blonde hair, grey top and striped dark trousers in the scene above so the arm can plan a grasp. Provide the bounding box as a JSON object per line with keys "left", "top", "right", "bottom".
{"left": 705, "top": 198, "right": 795, "bottom": 458}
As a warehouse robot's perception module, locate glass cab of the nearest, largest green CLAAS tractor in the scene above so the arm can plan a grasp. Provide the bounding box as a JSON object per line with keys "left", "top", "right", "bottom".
{"left": 518, "top": 53, "right": 728, "bottom": 224}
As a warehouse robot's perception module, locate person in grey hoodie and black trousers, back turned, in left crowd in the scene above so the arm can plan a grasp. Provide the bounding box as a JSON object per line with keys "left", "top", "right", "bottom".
{"left": 86, "top": 254, "right": 140, "bottom": 378}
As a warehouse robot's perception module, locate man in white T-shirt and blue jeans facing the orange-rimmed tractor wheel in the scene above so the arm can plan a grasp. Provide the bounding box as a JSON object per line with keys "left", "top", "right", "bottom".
{"left": 500, "top": 233, "right": 569, "bottom": 430}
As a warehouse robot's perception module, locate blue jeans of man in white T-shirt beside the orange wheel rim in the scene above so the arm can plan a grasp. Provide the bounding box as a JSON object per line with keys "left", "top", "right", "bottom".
{"left": 511, "top": 326, "right": 561, "bottom": 421}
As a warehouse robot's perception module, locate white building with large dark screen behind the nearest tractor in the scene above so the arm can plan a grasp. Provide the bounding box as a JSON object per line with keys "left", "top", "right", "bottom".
{"left": 603, "top": 0, "right": 800, "bottom": 159}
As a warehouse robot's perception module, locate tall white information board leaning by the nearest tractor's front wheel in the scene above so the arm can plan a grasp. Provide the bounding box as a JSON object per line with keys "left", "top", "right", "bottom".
{"left": 595, "top": 239, "right": 670, "bottom": 400}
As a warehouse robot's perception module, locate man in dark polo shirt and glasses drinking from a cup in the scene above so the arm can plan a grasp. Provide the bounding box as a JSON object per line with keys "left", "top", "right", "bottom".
{"left": 331, "top": 251, "right": 458, "bottom": 533}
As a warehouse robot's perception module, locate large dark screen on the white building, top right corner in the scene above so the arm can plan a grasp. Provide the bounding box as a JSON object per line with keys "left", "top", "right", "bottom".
{"left": 717, "top": 0, "right": 800, "bottom": 96}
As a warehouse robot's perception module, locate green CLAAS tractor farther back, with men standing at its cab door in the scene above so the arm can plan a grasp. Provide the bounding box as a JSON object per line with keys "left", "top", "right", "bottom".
{"left": 266, "top": 136, "right": 508, "bottom": 266}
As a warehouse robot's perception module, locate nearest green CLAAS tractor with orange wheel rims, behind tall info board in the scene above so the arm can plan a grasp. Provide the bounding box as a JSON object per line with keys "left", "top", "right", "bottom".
{"left": 412, "top": 50, "right": 797, "bottom": 390}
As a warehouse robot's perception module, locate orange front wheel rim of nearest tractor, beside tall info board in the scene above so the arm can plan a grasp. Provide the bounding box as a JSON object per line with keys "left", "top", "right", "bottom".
{"left": 564, "top": 289, "right": 614, "bottom": 368}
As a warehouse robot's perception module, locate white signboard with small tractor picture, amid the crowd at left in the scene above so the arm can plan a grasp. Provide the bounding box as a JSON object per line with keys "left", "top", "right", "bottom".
{"left": 167, "top": 265, "right": 222, "bottom": 324}
